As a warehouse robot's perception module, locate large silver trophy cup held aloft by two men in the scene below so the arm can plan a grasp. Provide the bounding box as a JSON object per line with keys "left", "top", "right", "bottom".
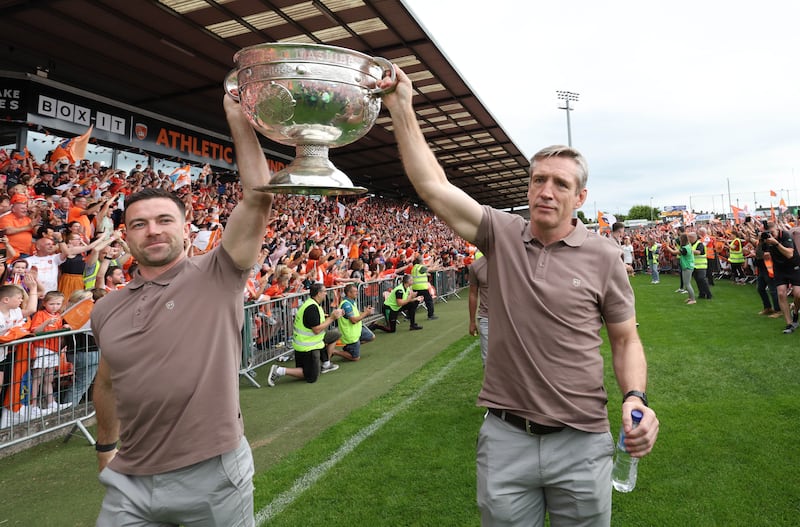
{"left": 225, "top": 43, "right": 395, "bottom": 195}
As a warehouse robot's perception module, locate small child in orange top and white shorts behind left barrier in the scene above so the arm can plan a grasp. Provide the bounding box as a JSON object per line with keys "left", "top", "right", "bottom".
{"left": 31, "top": 291, "right": 72, "bottom": 414}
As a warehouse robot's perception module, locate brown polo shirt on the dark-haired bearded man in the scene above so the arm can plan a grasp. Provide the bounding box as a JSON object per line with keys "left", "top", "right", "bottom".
{"left": 92, "top": 246, "right": 250, "bottom": 475}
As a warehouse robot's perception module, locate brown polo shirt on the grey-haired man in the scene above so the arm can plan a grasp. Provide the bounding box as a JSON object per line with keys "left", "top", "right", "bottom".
{"left": 475, "top": 206, "right": 634, "bottom": 432}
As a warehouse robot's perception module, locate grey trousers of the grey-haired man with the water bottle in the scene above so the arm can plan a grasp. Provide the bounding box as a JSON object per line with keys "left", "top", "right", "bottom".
{"left": 477, "top": 414, "right": 614, "bottom": 527}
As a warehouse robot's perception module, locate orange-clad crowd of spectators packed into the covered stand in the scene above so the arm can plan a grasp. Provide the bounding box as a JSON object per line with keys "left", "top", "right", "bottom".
{"left": 0, "top": 151, "right": 471, "bottom": 312}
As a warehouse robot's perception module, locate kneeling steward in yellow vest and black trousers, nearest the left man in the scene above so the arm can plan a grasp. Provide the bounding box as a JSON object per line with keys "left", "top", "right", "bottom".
{"left": 267, "top": 282, "right": 342, "bottom": 386}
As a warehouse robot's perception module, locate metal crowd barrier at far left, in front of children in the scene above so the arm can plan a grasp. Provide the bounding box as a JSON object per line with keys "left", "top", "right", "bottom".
{"left": 0, "top": 330, "right": 100, "bottom": 450}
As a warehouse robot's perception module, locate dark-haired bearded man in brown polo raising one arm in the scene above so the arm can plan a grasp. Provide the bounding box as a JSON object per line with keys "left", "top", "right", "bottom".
{"left": 92, "top": 96, "right": 272, "bottom": 527}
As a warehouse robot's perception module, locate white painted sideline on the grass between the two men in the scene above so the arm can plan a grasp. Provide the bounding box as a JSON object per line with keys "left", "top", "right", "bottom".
{"left": 256, "top": 342, "right": 479, "bottom": 527}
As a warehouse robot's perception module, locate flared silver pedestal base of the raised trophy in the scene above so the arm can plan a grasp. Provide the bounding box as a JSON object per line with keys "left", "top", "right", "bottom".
{"left": 253, "top": 145, "right": 367, "bottom": 196}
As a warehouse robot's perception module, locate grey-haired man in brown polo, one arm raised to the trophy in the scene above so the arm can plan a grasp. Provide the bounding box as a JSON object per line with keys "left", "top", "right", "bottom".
{"left": 379, "top": 67, "right": 658, "bottom": 526}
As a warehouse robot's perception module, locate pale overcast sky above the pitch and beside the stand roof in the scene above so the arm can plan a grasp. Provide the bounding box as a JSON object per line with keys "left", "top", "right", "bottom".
{"left": 404, "top": 0, "right": 800, "bottom": 217}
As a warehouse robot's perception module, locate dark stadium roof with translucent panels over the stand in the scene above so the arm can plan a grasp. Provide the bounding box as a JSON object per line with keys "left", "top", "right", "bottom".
{"left": 0, "top": 0, "right": 528, "bottom": 208}
